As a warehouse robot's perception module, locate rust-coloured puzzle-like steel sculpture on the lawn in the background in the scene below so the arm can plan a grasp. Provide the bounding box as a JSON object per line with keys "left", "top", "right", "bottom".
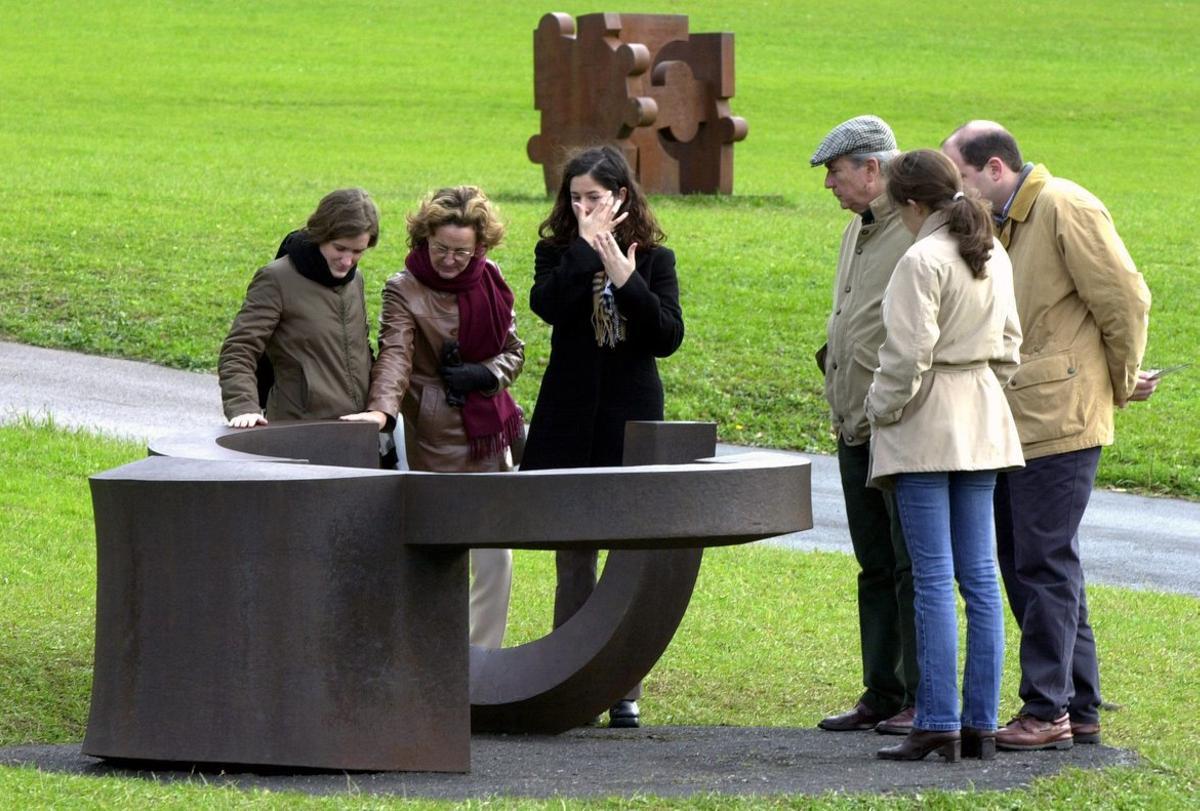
{"left": 527, "top": 13, "right": 748, "bottom": 194}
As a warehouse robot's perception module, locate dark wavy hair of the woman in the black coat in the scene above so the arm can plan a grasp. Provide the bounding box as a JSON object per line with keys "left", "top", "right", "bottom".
{"left": 538, "top": 146, "right": 666, "bottom": 251}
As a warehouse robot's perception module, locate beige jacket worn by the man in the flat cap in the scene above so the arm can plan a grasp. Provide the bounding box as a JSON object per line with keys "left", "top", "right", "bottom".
{"left": 824, "top": 193, "right": 912, "bottom": 445}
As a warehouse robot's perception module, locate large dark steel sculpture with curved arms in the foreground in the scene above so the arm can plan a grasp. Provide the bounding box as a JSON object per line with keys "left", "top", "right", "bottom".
{"left": 83, "top": 422, "right": 811, "bottom": 771}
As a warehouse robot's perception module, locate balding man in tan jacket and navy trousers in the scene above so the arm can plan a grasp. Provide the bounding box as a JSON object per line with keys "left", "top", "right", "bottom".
{"left": 942, "top": 121, "right": 1157, "bottom": 750}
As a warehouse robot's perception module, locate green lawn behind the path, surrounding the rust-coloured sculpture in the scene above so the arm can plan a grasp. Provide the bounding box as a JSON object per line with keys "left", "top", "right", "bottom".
{"left": 0, "top": 0, "right": 1200, "bottom": 497}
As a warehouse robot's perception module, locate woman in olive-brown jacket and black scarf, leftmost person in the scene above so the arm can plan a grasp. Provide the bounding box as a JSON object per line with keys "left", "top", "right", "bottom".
{"left": 218, "top": 188, "right": 379, "bottom": 428}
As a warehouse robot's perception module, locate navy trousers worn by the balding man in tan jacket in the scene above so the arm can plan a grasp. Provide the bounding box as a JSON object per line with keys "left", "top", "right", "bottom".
{"left": 996, "top": 447, "right": 1100, "bottom": 723}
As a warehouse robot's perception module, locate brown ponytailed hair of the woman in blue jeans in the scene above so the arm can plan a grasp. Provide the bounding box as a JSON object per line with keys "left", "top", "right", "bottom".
{"left": 888, "top": 149, "right": 992, "bottom": 278}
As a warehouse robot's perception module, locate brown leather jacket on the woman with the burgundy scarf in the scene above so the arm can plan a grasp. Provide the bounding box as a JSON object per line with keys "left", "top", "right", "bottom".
{"left": 367, "top": 272, "right": 524, "bottom": 473}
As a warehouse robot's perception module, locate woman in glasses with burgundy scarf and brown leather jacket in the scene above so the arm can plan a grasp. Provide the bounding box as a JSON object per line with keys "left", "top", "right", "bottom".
{"left": 342, "top": 186, "right": 524, "bottom": 648}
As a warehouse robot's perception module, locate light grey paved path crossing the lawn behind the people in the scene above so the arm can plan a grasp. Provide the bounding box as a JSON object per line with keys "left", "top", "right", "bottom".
{"left": 0, "top": 342, "right": 1200, "bottom": 596}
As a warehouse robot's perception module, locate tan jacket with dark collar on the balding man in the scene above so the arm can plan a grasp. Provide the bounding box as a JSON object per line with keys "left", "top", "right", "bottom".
{"left": 1000, "top": 164, "right": 1150, "bottom": 458}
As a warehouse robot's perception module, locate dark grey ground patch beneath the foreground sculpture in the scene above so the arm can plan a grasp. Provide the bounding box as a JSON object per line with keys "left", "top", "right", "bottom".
{"left": 0, "top": 727, "right": 1138, "bottom": 805}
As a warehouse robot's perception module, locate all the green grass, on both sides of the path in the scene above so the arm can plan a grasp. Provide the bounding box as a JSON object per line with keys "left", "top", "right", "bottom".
{"left": 0, "top": 0, "right": 1200, "bottom": 809}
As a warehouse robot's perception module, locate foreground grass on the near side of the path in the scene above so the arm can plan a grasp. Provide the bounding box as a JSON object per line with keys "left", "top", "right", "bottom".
{"left": 0, "top": 422, "right": 1200, "bottom": 809}
